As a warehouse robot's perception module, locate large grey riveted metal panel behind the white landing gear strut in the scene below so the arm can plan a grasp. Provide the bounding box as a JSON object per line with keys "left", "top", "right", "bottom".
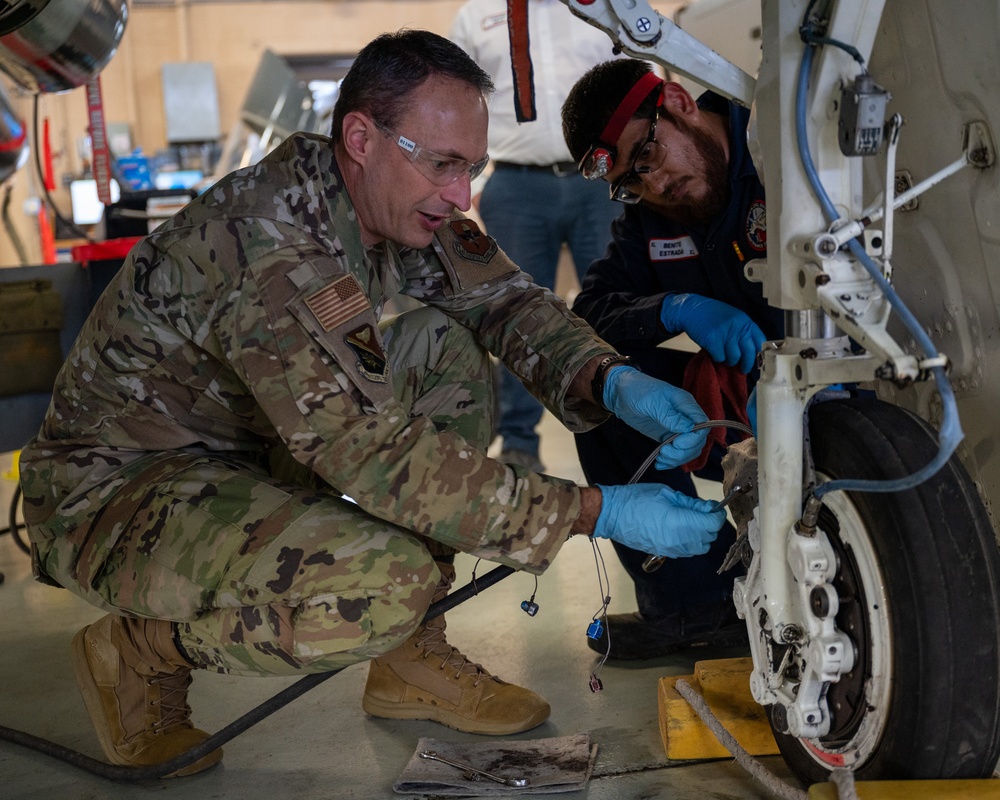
{"left": 865, "top": 0, "right": 1000, "bottom": 528}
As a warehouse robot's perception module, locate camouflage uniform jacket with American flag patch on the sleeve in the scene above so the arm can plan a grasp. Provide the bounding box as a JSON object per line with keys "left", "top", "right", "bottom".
{"left": 21, "top": 134, "right": 613, "bottom": 572}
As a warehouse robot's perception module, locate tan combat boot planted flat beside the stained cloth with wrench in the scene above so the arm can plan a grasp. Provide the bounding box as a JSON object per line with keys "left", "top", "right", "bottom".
{"left": 361, "top": 563, "right": 551, "bottom": 736}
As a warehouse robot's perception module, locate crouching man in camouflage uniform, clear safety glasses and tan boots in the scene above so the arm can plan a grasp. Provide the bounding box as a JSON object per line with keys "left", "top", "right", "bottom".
{"left": 21, "top": 31, "right": 724, "bottom": 774}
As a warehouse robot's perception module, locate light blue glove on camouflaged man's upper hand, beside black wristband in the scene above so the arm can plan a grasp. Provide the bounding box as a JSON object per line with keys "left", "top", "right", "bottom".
{"left": 602, "top": 366, "right": 708, "bottom": 469}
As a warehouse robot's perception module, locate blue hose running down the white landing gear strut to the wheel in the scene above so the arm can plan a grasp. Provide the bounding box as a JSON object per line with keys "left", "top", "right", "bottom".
{"left": 795, "top": 3, "right": 963, "bottom": 500}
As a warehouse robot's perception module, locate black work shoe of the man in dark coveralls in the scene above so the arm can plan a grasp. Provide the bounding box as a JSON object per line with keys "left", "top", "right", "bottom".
{"left": 587, "top": 611, "right": 749, "bottom": 661}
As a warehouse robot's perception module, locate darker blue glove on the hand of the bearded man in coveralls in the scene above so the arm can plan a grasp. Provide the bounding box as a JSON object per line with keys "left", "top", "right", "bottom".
{"left": 660, "top": 294, "right": 767, "bottom": 375}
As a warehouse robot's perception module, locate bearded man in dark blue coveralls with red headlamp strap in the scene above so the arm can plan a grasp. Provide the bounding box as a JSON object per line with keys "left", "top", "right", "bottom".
{"left": 562, "top": 54, "right": 783, "bottom": 659}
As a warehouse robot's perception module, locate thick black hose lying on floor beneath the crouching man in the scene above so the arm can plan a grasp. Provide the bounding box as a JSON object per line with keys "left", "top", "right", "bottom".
{"left": 0, "top": 565, "right": 515, "bottom": 782}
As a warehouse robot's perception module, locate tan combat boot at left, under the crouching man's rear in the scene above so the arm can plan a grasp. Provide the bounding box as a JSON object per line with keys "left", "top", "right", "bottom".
{"left": 73, "top": 614, "right": 222, "bottom": 778}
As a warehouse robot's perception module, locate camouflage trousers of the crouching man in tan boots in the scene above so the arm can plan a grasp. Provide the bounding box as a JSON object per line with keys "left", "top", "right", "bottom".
{"left": 56, "top": 307, "right": 494, "bottom": 675}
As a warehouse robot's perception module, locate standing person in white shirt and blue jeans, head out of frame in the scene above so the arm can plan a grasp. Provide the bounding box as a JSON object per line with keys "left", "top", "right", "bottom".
{"left": 448, "top": 0, "right": 621, "bottom": 472}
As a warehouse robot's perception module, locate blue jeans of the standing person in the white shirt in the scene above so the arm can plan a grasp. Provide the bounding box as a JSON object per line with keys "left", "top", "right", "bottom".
{"left": 479, "top": 166, "right": 622, "bottom": 456}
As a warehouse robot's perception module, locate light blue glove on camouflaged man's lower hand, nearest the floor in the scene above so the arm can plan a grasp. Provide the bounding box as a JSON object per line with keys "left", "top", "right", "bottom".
{"left": 594, "top": 483, "right": 726, "bottom": 558}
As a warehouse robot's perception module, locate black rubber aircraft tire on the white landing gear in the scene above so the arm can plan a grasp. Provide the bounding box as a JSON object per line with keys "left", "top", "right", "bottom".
{"left": 772, "top": 398, "right": 1000, "bottom": 784}
